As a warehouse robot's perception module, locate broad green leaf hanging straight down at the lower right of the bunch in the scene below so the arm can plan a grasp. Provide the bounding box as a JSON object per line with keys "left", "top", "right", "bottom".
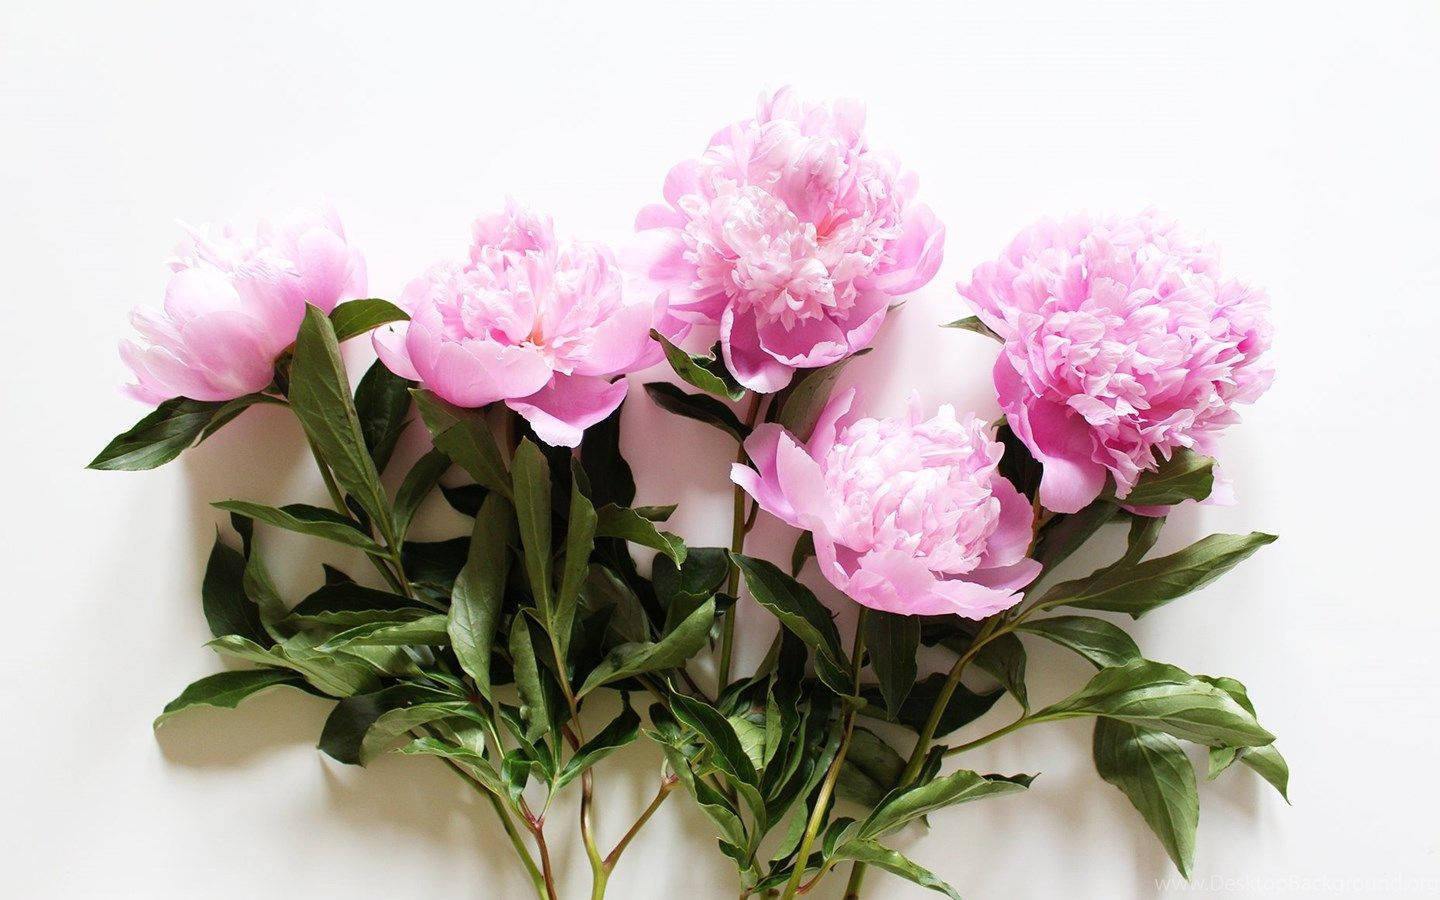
{"left": 1093, "top": 717, "right": 1200, "bottom": 878}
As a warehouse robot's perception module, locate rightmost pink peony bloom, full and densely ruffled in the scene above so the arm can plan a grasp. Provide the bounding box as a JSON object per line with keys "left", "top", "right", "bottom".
{"left": 959, "top": 212, "right": 1273, "bottom": 513}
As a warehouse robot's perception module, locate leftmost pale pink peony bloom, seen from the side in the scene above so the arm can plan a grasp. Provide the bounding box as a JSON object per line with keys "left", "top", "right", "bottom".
{"left": 120, "top": 204, "right": 366, "bottom": 403}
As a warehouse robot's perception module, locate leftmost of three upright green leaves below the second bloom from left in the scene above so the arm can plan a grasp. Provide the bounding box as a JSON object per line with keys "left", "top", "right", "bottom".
{"left": 449, "top": 494, "right": 516, "bottom": 698}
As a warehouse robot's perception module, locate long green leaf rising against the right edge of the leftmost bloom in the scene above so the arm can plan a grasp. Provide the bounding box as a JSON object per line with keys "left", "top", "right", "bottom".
{"left": 289, "top": 305, "right": 395, "bottom": 540}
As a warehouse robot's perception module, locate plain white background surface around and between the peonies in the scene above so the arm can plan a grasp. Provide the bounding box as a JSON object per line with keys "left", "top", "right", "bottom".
{"left": 0, "top": 0, "right": 1440, "bottom": 900}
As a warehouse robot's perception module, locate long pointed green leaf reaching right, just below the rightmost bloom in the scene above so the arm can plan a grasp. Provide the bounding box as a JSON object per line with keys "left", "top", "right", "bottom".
{"left": 1041, "top": 531, "right": 1276, "bottom": 619}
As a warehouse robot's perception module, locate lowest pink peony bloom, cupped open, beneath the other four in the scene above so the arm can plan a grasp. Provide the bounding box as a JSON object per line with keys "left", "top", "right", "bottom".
{"left": 730, "top": 389, "right": 1040, "bottom": 619}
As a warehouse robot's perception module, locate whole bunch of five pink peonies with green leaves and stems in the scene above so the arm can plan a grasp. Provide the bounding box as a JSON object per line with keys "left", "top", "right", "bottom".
{"left": 92, "top": 91, "right": 1287, "bottom": 900}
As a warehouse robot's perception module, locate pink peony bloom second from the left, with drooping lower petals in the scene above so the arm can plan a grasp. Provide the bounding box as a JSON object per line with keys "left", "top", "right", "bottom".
{"left": 374, "top": 202, "right": 664, "bottom": 446}
